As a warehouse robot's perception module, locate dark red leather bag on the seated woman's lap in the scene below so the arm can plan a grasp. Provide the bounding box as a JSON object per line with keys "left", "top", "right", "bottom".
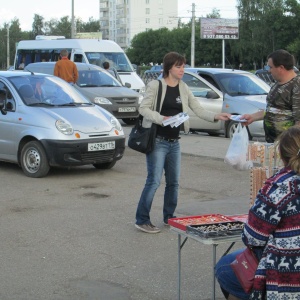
{"left": 230, "top": 247, "right": 258, "bottom": 294}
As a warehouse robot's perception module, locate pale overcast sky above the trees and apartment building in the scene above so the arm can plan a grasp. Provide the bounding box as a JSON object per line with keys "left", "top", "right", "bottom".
{"left": 0, "top": 0, "right": 237, "bottom": 31}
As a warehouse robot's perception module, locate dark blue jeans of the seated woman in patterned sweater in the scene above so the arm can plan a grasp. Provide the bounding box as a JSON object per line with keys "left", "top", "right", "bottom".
{"left": 215, "top": 249, "right": 250, "bottom": 300}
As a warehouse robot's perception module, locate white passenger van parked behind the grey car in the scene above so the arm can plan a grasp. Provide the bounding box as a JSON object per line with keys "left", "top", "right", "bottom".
{"left": 14, "top": 36, "right": 145, "bottom": 93}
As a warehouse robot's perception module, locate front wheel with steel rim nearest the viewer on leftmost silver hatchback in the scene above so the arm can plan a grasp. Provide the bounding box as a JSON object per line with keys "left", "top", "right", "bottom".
{"left": 20, "top": 141, "right": 50, "bottom": 178}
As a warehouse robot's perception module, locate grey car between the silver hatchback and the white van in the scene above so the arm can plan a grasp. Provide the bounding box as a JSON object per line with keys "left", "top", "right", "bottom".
{"left": 25, "top": 62, "right": 143, "bottom": 124}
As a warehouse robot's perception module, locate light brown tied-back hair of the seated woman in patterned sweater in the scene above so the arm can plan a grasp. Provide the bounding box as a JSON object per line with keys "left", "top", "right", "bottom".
{"left": 276, "top": 126, "right": 300, "bottom": 174}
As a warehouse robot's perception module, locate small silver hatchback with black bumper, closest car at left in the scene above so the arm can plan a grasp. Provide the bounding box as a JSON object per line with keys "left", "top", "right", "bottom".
{"left": 0, "top": 71, "right": 125, "bottom": 178}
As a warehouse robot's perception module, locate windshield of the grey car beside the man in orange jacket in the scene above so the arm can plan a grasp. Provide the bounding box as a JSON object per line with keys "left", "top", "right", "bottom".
{"left": 77, "top": 70, "right": 121, "bottom": 88}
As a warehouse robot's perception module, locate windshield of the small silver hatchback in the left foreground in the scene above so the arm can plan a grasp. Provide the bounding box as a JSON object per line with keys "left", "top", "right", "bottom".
{"left": 10, "top": 75, "right": 92, "bottom": 106}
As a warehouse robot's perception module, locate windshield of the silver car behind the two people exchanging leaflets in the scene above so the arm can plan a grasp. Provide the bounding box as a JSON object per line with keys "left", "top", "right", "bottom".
{"left": 216, "top": 73, "right": 270, "bottom": 96}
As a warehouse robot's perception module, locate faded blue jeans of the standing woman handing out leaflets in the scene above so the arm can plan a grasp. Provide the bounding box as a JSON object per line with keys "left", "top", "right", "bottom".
{"left": 136, "top": 138, "right": 181, "bottom": 225}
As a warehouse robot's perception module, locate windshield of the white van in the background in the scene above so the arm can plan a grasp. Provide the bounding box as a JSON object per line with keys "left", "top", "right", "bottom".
{"left": 85, "top": 52, "right": 134, "bottom": 72}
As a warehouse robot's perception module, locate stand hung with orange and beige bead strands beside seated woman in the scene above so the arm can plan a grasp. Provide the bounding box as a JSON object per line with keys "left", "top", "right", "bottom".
{"left": 248, "top": 142, "right": 283, "bottom": 206}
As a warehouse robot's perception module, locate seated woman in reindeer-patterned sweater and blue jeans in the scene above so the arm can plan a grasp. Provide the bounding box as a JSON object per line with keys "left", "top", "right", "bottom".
{"left": 215, "top": 126, "right": 300, "bottom": 300}
